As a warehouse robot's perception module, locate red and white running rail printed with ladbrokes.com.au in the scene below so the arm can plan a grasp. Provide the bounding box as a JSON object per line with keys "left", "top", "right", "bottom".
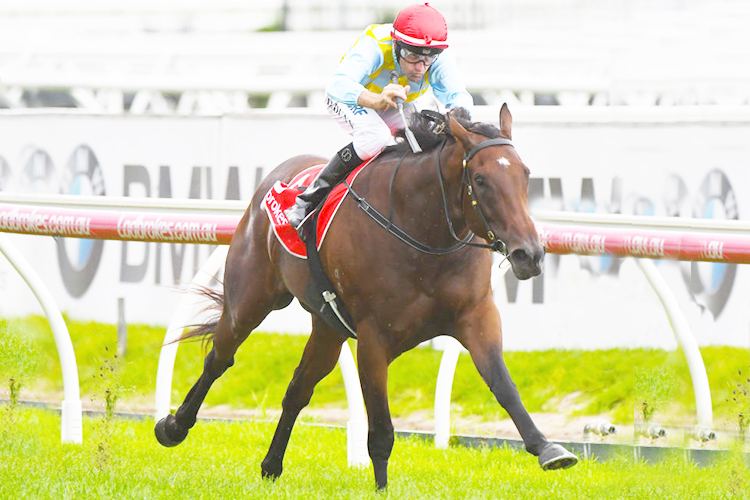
{"left": 0, "top": 203, "right": 750, "bottom": 264}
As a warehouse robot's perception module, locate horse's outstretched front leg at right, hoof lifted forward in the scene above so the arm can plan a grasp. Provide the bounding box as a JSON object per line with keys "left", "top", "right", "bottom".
{"left": 456, "top": 298, "right": 578, "bottom": 470}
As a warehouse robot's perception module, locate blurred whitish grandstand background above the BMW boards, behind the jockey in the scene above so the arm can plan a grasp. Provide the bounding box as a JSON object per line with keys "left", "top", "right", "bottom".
{"left": 0, "top": 0, "right": 750, "bottom": 115}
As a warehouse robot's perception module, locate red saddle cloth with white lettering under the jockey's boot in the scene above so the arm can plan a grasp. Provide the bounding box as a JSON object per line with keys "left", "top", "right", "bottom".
{"left": 262, "top": 160, "right": 372, "bottom": 259}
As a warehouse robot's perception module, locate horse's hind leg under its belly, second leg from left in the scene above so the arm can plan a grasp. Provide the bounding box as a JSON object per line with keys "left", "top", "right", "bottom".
{"left": 261, "top": 316, "right": 344, "bottom": 479}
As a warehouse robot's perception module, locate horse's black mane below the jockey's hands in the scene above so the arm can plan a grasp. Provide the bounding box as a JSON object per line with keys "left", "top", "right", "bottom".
{"left": 385, "top": 108, "right": 500, "bottom": 153}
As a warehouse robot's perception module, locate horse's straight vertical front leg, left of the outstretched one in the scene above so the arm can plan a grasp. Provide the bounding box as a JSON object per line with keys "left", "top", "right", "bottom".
{"left": 357, "top": 328, "right": 393, "bottom": 490}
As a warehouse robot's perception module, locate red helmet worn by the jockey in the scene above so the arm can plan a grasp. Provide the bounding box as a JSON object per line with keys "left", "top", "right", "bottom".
{"left": 391, "top": 2, "right": 448, "bottom": 50}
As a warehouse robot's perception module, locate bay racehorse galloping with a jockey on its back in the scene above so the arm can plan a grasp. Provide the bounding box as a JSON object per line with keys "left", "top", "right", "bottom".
{"left": 155, "top": 105, "right": 578, "bottom": 489}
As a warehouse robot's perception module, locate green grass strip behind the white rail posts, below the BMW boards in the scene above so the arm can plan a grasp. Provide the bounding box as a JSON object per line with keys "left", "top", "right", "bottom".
{"left": 0, "top": 317, "right": 750, "bottom": 429}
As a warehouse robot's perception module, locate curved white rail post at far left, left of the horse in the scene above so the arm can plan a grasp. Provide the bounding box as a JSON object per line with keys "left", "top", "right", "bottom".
{"left": 0, "top": 233, "right": 83, "bottom": 444}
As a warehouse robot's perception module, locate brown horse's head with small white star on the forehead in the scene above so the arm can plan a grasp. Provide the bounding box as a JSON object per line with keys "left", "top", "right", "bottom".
{"left": 449, "top": 104, "right": 544, "bottom": 280}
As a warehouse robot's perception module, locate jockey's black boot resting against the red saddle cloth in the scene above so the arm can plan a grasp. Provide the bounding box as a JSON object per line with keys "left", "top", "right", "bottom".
{"left": 284, "top": 144, "right": 362, "bottom": 231}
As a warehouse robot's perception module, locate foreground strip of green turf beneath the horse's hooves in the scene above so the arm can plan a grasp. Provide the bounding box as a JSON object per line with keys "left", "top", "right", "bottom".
{"left": 0, "top": 407, "right": 750, "bottom": 500}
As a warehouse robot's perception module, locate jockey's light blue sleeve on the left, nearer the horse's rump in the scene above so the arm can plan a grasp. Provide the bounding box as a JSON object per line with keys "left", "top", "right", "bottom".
{"left": 326, "top": 32, "right": 384, "bottom": 105}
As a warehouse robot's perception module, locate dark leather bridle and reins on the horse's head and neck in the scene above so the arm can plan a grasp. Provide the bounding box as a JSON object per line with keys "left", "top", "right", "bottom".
{"left": 344, "top": 137, "right": 513, "bottom": 257}
